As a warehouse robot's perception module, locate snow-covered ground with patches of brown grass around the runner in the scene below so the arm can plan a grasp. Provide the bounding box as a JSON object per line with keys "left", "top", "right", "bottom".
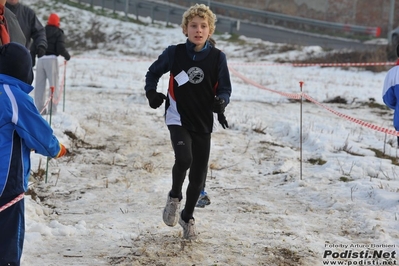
{"left": 11, "top": 0, "right": 399, "bottom": 266}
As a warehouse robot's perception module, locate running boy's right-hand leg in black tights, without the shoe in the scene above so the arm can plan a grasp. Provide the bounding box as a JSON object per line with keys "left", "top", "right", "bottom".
{"left": 182, "top": 132, "right": 211, "bottom": 222}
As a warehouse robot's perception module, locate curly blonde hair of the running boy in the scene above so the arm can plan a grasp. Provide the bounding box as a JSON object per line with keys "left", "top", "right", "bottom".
{"left": 180, "top": 4, "right": 216, "bottom": 35}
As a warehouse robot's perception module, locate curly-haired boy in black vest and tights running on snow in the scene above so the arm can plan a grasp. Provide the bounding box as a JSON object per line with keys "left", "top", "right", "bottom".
{"left": 144, "top": 4, "right": 232, "bottom": 240}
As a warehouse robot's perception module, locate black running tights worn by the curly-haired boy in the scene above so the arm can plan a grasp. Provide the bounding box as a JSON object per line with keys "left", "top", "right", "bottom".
{"left": 168, "top": 126, "right": 211, "bottom": 222}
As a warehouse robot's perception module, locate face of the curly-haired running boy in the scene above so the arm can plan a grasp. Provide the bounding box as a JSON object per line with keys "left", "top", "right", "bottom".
{"left": 183, "top": 16, "right": 211, "bottom": 51}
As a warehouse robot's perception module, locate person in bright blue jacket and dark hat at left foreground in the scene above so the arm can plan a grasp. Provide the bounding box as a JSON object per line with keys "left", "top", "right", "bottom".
{"left": 0, "top": 42, "right": 67, "bottom": 266}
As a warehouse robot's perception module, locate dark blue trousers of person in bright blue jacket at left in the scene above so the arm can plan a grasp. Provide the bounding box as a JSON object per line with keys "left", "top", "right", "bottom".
{"left": 0, "top": 195, "right": 25, "bottom": 266}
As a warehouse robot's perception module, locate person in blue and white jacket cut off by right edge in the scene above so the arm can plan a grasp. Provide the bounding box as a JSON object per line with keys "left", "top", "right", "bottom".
{"left": 382, "top": 45, "right": 399, "bottom": 147}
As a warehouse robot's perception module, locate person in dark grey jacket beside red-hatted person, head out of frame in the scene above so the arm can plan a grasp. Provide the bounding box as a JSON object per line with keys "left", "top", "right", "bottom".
{"left": 6, "top": 0, "right": 47, "bottom": 63}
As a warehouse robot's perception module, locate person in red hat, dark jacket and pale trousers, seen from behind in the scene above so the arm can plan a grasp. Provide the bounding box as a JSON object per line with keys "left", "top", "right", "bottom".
{"left": 35, "top": 13, "right": 71, "bottom": 114}
